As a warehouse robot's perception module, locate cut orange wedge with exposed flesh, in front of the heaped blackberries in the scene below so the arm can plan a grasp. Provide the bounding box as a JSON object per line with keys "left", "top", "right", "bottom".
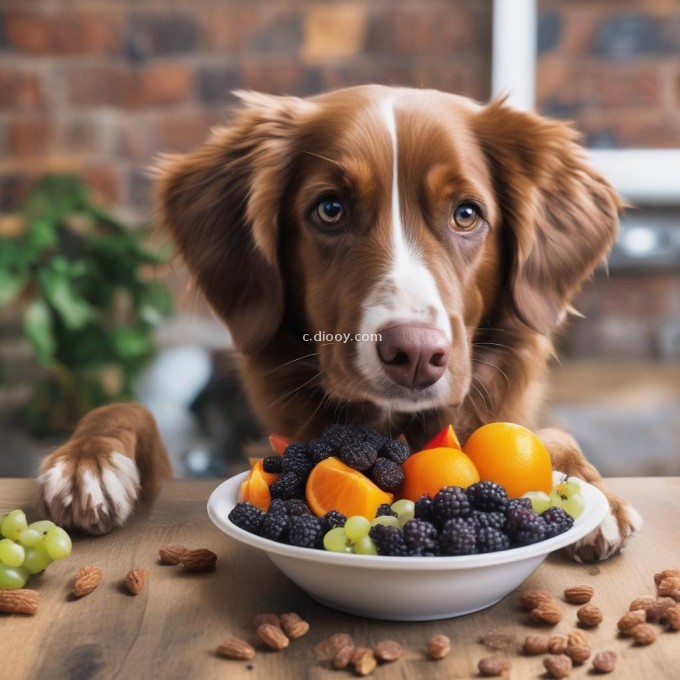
{"left": 305, "top": 457, "right": 393, "bottom": 519}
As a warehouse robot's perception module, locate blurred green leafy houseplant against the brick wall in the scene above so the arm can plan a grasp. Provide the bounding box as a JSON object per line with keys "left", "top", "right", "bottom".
{"left": 0, "top": 175, "right": 171, "bottom": 435}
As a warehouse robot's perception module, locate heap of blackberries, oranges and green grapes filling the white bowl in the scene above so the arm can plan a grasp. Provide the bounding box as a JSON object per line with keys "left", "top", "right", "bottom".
{"left": 229, "top": 423, "right": 583, "bottom": 556}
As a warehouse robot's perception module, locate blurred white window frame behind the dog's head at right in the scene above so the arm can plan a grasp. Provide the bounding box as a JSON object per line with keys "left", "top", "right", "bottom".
{"left": 491, "top": 0, "right": 680, "bottom": 206}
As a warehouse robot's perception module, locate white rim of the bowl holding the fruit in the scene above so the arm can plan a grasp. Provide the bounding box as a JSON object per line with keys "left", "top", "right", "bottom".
{"left": 207, "top": 471, "right": 609, "bottom": 571}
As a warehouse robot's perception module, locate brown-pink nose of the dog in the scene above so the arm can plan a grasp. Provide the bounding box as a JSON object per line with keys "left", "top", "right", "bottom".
{"left": 376, "top": 324, "right": 451, "bottom": 388}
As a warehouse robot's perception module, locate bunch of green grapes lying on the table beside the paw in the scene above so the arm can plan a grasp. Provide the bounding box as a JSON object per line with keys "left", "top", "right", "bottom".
{"left": 0, "top": 510, "right": 71, "bottom": 590}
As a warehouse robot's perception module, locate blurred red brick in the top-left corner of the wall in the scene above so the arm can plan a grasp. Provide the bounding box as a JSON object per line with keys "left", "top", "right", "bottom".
{"left": 5, "top": 10, "right": 125, "bottom": 54}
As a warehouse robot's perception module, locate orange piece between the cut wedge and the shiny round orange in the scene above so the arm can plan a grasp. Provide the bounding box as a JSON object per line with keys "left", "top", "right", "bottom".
{"left": 398, "top": 446, "right": 479, "bottom": 501}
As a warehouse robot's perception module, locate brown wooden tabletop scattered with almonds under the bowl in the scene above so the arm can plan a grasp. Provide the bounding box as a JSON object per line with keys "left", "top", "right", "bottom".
{"left": 0, "top": 478, "right": 680, "bottom": 680}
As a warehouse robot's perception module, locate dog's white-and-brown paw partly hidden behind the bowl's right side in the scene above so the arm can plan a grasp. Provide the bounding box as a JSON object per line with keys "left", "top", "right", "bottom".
{"left": 565, "top": 491, "right": 642, "bottom": 562}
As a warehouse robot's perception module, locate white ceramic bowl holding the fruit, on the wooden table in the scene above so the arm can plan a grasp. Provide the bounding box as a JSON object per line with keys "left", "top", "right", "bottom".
{"left": 208, "top": 472, "right": 609, "bottom": 621}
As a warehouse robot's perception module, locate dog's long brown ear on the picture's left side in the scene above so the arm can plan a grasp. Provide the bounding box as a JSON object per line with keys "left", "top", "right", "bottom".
{"left": 156, "top": 92, "right": 315, "bottom": 354}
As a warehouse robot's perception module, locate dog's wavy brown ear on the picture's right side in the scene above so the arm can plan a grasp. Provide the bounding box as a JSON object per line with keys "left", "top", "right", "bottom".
{"left": 475, "top": 100, "right": 622, "bottom": 335}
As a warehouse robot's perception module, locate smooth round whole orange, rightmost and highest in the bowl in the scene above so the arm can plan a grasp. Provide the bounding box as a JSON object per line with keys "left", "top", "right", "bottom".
{"left": 463, "top": 423, "right": 552, "bottom": 498}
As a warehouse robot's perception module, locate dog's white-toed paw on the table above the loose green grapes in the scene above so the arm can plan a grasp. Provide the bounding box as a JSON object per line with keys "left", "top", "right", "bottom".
{"left": 36, "top": 437, "right": 140, "bottom": 534}
